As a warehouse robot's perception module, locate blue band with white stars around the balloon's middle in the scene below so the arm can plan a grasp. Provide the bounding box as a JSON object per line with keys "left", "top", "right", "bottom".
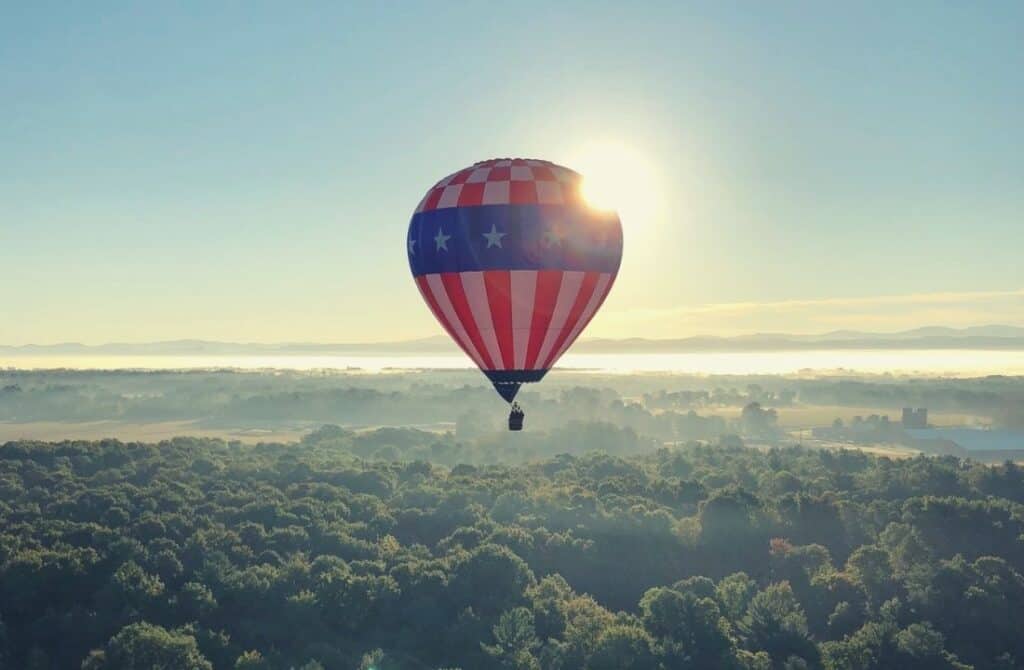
{"left": 407, "top": 205, "right": 623, "bottom": 277}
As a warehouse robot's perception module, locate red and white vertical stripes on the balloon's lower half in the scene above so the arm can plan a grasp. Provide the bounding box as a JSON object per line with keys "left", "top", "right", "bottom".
{"left": 416, "top": 269, "right": 614, "bottom": 370}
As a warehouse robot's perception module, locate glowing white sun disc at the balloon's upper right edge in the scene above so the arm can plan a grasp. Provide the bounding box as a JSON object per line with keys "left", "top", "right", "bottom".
{"left": 570, "top": 141, "right": 659, "bottom": 224}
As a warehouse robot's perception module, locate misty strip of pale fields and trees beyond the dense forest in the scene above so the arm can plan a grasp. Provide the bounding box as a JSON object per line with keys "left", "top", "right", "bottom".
{"left": 0, "top": 370, "right": 1024, "bottom": 441}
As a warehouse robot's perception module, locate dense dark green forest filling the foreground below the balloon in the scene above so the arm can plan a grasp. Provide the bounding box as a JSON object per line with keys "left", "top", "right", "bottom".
{"left": 0, "top": 428, "right": 1024, "bottom": 670}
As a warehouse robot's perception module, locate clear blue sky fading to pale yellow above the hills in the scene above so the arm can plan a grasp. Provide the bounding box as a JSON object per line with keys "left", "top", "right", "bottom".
{"left": 0, "top": 1, "right": 1024, "bottom": 344}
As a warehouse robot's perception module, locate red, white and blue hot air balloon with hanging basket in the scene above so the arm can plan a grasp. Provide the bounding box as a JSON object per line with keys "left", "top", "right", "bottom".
{"left": 407, "top": 159, "right": 623, "bottom": 430}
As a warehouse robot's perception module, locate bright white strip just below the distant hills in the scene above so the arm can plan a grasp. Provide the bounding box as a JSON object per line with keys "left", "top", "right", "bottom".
{"left": 0, "top": 349, "right": 1024, "bottom": 377}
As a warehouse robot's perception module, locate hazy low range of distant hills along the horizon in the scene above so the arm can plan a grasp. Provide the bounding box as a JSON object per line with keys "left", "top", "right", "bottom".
{"left": 6, "top": 326, "right": 1024, "bottom": 357}
